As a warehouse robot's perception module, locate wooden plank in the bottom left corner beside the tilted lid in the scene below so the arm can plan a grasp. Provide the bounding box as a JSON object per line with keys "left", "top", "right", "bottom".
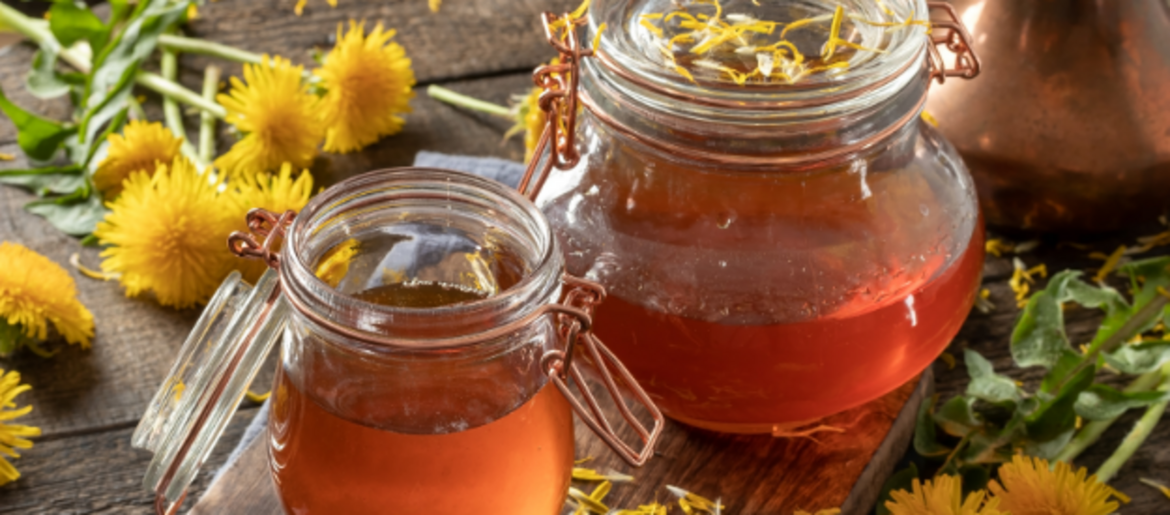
{"left": 0, "top": 408, "right": 257, "bottom": 515}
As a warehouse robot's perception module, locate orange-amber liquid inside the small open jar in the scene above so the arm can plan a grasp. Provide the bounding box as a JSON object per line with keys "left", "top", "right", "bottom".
{"left": 269, "top": 235, "right": 573, "bottom": 515}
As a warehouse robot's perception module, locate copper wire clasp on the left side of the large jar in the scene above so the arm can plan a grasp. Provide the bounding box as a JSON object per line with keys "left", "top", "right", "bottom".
{"left": 516, "top": 13, "right": 593, "bottom": 200}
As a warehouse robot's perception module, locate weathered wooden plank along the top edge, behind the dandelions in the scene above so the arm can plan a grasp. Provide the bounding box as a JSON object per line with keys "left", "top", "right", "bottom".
{"left": 183, "top": 0, "right": 580, "bottom": 84}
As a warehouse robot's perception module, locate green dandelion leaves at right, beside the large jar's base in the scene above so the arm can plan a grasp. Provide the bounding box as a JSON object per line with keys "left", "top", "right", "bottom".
{"left": 914, "top": 258, "right": 1170, "bottom": 488}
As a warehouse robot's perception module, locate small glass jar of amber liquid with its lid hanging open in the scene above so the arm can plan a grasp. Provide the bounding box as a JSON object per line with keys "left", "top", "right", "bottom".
{"left": 135, "top": 169, "right": 661, "bottom": 515}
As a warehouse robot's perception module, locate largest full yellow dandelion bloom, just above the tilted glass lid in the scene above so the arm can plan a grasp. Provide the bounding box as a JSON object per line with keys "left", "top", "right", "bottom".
{"left": 94, "top": 158, "right": 239, "bottom": 308}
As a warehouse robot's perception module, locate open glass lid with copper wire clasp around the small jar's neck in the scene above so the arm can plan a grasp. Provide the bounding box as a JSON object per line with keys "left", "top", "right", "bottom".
{"left": 132, "top": 169, "right": 665, "bottom": 514}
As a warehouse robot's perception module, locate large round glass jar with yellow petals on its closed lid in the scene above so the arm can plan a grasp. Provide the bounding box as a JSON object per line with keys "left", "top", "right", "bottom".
{"left": 537, "top": 0, "right": 983, "bottom": 434}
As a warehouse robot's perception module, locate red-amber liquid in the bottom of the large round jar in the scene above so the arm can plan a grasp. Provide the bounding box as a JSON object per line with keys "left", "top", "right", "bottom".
{"left": 596, "top": 233, "right": 983, "bottom": 433}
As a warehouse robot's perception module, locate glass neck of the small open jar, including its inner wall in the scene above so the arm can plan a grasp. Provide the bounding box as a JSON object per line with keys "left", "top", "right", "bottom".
{"left": 281, "top": 169, "right": 564, "bottom": 355}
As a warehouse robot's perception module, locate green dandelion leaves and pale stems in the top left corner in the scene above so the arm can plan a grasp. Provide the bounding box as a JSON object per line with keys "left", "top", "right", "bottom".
{"left": 0, "top": 0, "right": 261, "bottom": 235}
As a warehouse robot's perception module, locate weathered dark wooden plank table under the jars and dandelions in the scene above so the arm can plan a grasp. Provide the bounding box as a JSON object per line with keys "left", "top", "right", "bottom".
{"left": 0, "top": 0, "right": 1170, "bottom": 514}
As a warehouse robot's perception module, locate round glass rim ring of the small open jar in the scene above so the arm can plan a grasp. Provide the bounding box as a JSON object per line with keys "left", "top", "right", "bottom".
{"left": 281, "top": 167, "right": 564, "bottom": 349}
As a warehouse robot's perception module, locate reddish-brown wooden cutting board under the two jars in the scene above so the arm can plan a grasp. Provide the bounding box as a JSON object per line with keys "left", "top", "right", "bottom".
{"left": 191, "top": 369, "right": 934, "bottom": 515}
